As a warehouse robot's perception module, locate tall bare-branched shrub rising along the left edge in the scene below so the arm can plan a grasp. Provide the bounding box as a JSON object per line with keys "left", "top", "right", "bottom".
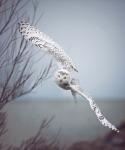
{"left": 0, "top": 0, "right": 52, "bottom": 109}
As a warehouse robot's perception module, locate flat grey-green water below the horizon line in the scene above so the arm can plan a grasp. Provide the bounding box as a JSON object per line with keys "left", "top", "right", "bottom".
{"left": 3, "top": 101, "right": 125, "bottom": 145}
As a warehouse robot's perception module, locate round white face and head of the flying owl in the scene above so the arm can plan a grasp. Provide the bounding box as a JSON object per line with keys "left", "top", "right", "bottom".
{"left": 55, "top": 69, "right": 71, "bottom": 90}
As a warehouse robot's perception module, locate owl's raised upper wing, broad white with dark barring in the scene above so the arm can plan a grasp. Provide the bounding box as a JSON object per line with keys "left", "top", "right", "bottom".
{"left": 19, "top": 21, "right": 77, "bottom": 71}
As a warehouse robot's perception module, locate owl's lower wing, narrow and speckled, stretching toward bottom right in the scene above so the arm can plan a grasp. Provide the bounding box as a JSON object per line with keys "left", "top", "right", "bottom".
{"left": 71, "top": 85, "right": 119, "bottom": 132}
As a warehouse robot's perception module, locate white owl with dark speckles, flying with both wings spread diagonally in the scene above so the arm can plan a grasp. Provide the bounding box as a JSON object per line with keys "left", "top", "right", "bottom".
{"left": 19, "top": 21, "right": 119, "bottom": 132}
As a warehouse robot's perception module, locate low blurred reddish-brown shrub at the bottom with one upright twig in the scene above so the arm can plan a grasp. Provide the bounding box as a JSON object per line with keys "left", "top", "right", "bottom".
{"left": 8, "top": 117, "right": 60, "bottom": 150}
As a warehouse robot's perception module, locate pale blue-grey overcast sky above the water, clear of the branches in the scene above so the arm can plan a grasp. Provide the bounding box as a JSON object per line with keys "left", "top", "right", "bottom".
{"left": 18, "top": 0, "right": 125, "bottom": 99}
